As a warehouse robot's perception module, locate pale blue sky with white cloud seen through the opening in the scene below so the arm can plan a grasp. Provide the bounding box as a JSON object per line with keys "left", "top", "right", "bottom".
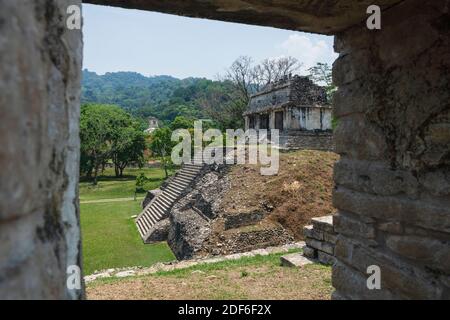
{"left": 83, "top": 4, "right": 337, "bottom": 79}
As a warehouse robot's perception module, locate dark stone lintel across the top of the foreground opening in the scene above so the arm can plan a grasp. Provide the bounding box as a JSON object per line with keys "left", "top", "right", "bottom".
{"left": 84, "top": 0, "right": 400, "bottom": 34}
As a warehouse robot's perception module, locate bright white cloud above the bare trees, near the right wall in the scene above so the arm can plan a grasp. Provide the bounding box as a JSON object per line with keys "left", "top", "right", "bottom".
{"left": 278, "top": 34, "right": 338, "bottom": 73}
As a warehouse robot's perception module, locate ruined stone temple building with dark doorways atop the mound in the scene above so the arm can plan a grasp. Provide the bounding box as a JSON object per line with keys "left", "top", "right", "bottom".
{"left": 244, "top": 75, "right": 333, "bottom": 150}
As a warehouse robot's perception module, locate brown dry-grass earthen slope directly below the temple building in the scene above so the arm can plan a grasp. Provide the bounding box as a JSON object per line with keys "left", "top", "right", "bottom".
{"left": 222, "top": 150, "right": 338, "bottom": 239}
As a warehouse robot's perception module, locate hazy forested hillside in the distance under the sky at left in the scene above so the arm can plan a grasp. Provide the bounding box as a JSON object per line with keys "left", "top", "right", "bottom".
{"left": 82, "top": 70, "right": 234, "bottom": 122}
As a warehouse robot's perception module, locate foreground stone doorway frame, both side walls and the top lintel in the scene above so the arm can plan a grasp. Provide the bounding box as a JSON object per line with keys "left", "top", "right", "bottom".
{"left": 0, "top": 0, "right": 450, "bottom": 299}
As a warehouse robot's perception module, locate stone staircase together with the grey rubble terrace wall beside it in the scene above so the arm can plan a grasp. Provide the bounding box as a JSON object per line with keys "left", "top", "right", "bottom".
{"left": 136, "top": 164, "right": 294, "bottom": 260}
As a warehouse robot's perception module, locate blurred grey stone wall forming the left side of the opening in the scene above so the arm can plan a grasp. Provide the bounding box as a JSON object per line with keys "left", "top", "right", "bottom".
{"left": 0, "top": 0, "right": 84, "bottom": 299}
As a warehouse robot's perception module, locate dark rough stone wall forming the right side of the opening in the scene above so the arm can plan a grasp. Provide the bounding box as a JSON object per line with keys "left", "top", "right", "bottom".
{"left": 333, "top": 0, "right": 450, "bottom": 299}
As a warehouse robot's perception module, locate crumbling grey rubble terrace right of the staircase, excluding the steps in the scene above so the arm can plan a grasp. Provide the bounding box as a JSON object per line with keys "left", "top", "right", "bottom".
{"left": 167, "top": 165, "right": 294, "bottom": 260}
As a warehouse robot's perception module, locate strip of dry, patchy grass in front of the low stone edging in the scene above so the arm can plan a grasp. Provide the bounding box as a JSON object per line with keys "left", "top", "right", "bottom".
{"left": 87, "top": 254, "right": 333, "bottom": 300}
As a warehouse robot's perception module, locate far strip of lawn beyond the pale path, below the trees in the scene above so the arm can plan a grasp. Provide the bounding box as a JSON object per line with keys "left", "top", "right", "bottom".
{"left": 80, "top": 168, "right": 173, "bottom": 201}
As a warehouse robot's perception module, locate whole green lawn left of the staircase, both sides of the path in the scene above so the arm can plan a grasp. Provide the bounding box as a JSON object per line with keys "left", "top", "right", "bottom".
{"left": 80, "top": 168, "right": 175, "bottom": 274}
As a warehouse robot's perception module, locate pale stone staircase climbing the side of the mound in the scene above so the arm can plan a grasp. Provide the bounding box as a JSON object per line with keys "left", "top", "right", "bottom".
{"left": 135, "top": 162, "right": 203, "bottom": 243}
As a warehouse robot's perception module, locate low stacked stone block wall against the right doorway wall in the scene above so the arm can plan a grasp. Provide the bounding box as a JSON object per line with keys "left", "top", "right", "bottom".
{"left": 303, "top": 216, "right": 337, "bottom": 264}
